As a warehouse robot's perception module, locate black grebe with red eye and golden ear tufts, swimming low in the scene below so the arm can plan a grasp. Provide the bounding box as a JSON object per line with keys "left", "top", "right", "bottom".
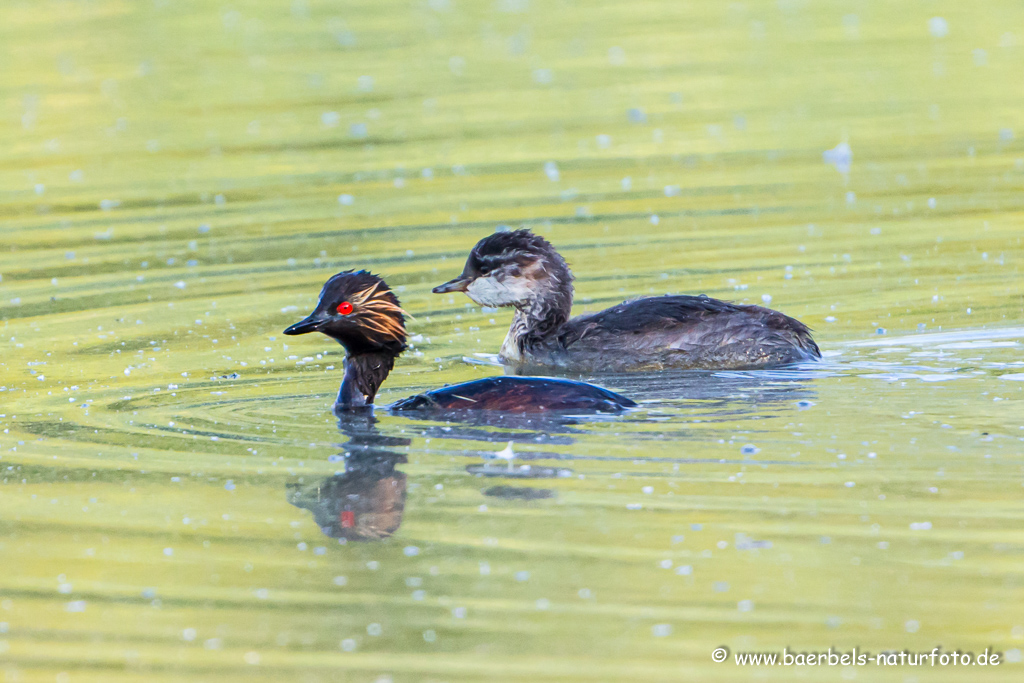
{"left": 285, "top": 270, "right": 636, "bottom": 413}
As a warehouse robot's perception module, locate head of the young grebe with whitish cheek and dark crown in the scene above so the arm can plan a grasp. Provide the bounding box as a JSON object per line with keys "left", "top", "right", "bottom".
{"left": 433, "top": 230, "right": 572, "bottom": 308}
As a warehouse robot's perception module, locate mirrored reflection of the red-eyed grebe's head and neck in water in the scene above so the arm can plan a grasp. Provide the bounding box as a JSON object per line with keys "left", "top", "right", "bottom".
{"left": 288, "top": 413, "right": 410, "bottom": 541}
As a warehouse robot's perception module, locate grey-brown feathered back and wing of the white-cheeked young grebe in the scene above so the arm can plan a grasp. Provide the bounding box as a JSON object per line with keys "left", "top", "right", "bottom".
{"left": 558, "top": 296, "right": 821, "bottom": 368}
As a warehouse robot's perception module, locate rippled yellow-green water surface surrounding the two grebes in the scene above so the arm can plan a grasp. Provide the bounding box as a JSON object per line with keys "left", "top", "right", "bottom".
{"left": 0, "top": 0, "right": 1024, "bottom": 681}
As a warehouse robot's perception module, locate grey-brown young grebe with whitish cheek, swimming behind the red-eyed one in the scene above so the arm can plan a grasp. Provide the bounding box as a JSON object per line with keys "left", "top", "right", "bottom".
{"left": 434, "top": 230, "right": 821, "bottom": 372}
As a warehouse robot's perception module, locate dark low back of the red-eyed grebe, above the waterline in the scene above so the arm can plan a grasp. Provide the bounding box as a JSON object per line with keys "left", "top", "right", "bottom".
{"left": 391, "top": 377, "right": 636, "bottom": 413}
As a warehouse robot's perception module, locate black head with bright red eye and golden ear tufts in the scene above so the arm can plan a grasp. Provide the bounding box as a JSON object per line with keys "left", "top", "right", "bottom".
{"left": 285, "top": 270, "right": 406, "bottom": 356}
